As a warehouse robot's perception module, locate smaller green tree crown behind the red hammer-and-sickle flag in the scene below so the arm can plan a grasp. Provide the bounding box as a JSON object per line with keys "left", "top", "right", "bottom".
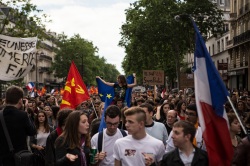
{"left": 52, "top": 34, "right": 119, "bottom": 85}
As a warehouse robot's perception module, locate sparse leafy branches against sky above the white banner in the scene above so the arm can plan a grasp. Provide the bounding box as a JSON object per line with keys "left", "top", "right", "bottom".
{"left": 0, "top": 0, "right": 50, "bottom": 39}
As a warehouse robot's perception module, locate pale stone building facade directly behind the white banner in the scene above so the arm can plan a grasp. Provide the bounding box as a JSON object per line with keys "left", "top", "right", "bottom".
{"left": 0, "top": 4, "right": 64, "bottom": 96}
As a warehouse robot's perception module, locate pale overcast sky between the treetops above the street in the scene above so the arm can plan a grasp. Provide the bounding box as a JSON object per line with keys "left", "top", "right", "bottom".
{"left": 31, "top": 0, "right": 136, "bottom": 74}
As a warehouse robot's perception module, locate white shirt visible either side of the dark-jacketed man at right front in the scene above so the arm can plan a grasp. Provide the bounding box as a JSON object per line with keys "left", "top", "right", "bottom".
{"left": 166, "top": 126, "right": 206, "bottom": 153}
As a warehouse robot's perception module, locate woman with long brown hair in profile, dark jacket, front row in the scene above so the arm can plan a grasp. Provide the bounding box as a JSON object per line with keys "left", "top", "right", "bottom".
{"left": 55, "top": 111, "right": 90, "bottom": 166}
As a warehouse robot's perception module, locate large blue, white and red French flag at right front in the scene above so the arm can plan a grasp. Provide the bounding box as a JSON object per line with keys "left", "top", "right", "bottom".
{"left": 192, "top": 20, "right": 233, "bottom": 166}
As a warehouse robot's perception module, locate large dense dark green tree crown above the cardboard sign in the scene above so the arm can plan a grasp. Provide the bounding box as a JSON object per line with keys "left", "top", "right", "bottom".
{"left": 119, "top": 0, "right": 222, "bottom": 85}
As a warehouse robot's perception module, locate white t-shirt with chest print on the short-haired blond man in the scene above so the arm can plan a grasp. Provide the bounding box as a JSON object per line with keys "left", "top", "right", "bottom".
{"left": 113, "top": 134, "right": 165, "bottom": 166}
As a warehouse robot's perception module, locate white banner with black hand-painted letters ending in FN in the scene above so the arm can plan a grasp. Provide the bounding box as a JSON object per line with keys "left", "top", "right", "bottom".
{"left": 0, "top": 35, "right": 37, "bottom": 81}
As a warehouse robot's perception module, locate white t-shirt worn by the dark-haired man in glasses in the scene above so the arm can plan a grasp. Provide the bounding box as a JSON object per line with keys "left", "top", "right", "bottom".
{"left": 91, "top": 129, "right": 127, "bottom": 166}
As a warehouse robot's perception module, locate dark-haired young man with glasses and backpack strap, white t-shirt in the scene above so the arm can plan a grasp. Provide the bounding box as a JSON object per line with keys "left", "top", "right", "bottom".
{"left": 91, "top": 105, "right": 127, "bottom": 166}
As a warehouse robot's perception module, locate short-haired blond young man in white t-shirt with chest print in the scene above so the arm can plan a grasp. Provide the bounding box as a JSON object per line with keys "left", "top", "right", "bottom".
{"left": 113, "top": 107, "right": 165, "bottom": 166}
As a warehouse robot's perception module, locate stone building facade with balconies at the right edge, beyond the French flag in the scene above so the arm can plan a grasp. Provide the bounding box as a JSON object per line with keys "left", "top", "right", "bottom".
{"left": 227, "top": 0, "right": 250, "bottom": 90}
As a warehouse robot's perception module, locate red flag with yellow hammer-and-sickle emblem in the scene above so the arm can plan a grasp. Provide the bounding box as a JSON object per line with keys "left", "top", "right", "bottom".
{"left": 60, "top": 61, "right": 89, "bottom": 109}
